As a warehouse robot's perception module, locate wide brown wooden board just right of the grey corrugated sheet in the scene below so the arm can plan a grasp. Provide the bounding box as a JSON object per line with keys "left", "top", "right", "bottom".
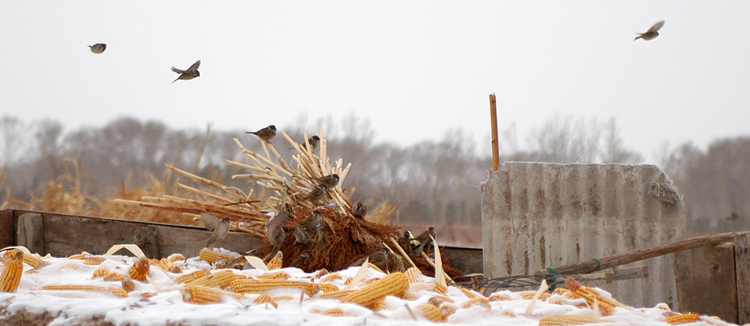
{"left": 672, "top": 244, "right": 737, "bottom": 323}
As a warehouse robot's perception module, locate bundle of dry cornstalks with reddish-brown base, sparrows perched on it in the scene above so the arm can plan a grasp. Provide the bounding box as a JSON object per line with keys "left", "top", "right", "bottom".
{"left": 115, "top": 131, "right": 410, "bottom": 271}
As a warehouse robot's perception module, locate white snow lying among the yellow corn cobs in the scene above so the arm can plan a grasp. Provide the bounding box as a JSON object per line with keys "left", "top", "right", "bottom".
{"left": 0, "top": 251, "right": 740, "bottom": 326}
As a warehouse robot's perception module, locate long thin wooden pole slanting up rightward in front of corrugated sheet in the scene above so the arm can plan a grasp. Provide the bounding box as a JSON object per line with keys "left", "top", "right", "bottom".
{"left": 536, "top": 232, "right": 749, "bottom": 275}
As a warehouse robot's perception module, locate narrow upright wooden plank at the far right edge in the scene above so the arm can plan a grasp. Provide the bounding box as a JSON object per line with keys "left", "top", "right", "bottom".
{"left": 734, "top": 233, "right": 750, "bottom": 325}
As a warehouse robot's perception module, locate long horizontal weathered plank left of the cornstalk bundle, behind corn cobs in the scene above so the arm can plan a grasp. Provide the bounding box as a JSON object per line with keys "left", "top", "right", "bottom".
{"left": 44, "top": 214, "right": 261, "bottom": 258}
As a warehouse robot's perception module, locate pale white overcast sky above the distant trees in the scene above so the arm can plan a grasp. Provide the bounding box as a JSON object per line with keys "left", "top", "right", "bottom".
{"left": 0, "top": 0, "right": 750, "bottom": 160}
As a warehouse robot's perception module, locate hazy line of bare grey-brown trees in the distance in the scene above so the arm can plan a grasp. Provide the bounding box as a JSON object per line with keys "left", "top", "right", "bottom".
{"left": 0, "top": 114, "right": 750, "bottom": 242}
